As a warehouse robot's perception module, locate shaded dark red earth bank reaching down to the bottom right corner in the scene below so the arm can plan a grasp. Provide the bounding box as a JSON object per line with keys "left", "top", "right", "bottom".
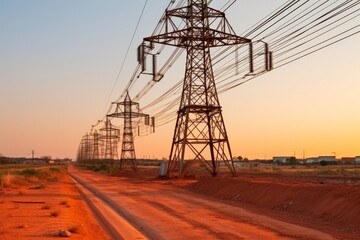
{"left": 186, "top": 173, "right": 360, "bottom": 239}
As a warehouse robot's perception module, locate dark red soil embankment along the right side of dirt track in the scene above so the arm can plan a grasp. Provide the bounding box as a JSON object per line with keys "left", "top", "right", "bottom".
{"left": 187, "top": 176, "right": 360, "bottom": 229}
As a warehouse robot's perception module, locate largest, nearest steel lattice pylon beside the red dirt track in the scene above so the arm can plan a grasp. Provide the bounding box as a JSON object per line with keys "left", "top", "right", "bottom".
{"left": 144, "top": 0, "right": 251, "bottom": 176}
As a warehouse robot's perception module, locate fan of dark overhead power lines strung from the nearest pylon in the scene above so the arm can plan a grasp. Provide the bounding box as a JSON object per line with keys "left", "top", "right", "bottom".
{"left": 87, "top": 0, "right": 359, "bottom": 141}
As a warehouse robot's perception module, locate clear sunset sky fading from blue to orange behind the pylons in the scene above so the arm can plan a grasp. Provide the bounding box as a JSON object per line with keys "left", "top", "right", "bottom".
{"left": 0, "top": 0, "right": 360, "bottom": 159}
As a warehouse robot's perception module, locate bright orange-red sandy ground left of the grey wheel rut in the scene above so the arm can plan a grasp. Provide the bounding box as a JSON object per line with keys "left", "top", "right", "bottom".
{"left": 0, "top": 169, "right": 109, "bottom": 240}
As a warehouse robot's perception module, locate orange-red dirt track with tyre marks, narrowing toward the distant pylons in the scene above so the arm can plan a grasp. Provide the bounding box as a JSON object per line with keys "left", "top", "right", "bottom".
{"left": 69, "top": 167, "right": 356, "bottom": 239}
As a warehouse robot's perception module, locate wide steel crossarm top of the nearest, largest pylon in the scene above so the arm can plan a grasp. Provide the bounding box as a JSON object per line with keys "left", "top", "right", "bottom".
{"left": 144, "top": 1, "right": 251, "bottom": 48}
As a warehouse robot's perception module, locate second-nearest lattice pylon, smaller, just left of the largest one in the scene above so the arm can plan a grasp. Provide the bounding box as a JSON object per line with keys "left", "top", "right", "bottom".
{"left": 107, "top": 92, "right": 149, "bottom": 171}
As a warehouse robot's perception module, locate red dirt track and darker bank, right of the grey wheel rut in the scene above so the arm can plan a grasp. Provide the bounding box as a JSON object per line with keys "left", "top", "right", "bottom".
{"left": 70, "top": 165, "right": 360, "bottom": 239}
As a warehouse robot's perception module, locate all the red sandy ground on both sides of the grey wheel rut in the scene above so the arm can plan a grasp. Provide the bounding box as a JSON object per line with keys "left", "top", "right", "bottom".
{"left": 0, "top": 166, "right": 360, "bottom": 240}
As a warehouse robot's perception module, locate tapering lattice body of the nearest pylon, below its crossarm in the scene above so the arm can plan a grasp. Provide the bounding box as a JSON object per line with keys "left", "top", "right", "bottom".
{"left": 167, "top": 45, "right": 235, "bottom": 176}
